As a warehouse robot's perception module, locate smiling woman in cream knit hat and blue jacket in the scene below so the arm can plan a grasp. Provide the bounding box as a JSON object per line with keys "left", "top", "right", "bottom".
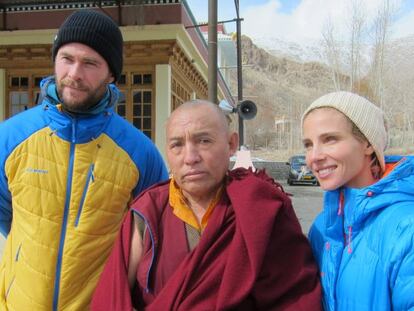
{"left": 302, "top": 92, "right": 414, "bottom": 311}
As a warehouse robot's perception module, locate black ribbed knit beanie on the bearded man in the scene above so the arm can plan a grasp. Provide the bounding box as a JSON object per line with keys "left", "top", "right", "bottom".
{"left": 52, "top": 9, "right": 123, "bottom": 81}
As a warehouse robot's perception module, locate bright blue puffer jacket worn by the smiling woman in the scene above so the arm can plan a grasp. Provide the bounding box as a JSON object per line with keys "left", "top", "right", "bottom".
{"left": 309, "top": 156, "right": 414, "bottom": 311}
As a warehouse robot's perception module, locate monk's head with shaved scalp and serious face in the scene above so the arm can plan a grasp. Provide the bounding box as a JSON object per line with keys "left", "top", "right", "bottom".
{"left": 166, "top": 104, "right": 238, "bottom": 199}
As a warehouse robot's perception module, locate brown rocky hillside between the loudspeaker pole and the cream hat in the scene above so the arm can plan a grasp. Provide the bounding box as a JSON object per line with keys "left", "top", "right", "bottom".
{"left": 233, "top": 36, "right": 334, "bottom": 149}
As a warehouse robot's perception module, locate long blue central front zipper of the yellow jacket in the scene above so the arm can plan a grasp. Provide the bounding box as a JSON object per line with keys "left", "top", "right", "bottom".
{"left": 53, "top": 119, "right": 76, "bottom": 311}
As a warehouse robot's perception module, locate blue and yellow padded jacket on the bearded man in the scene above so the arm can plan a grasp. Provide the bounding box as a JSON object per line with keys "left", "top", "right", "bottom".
{"left": 0, "top": 78, "right": 168, "bottom": 310}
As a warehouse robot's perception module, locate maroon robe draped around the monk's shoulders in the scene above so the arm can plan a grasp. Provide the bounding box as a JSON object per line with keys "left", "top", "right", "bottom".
{"left": 91, "top": 169, "right": 321, "bottom": 311}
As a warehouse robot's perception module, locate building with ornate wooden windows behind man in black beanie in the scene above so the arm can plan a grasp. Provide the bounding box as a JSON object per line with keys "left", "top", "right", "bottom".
{"left": 0, "top": 0, "right": 233, "bottom": 156}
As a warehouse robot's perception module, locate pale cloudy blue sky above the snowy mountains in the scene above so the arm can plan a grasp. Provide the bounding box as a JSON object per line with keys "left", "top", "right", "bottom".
{"left": 187, "top": 0, "right": 414, "bottom": 42}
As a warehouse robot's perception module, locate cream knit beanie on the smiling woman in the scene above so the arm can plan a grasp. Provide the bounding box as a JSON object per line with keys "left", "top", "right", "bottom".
{"left": 302, "top": 91, "right": 388, "bottom": 171}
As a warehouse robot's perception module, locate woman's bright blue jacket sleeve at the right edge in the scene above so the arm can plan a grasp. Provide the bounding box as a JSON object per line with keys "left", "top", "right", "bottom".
{"left": 391, "top": 223, "right": 414, "bottom": 310}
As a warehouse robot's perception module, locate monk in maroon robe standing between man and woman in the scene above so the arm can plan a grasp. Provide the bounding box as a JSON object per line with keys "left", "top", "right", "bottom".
{"left": 92, "top": 100, "right": 321, "bottom": 311}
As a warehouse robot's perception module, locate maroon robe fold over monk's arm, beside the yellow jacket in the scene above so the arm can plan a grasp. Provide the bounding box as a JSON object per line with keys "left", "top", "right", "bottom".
{"left": 91, "top": 211, "right": 133, "bottom": 311}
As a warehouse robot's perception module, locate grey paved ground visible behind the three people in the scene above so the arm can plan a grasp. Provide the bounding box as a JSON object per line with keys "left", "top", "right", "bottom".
{"left": 0, "top": 181, "right": 322, "bottom": 254}
